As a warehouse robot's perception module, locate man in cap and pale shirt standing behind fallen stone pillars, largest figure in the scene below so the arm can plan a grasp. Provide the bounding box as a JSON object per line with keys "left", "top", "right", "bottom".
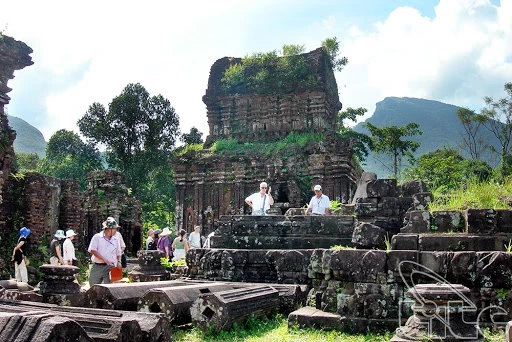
{"left": 88, "top": 217, "right": 123, "bottom": 286}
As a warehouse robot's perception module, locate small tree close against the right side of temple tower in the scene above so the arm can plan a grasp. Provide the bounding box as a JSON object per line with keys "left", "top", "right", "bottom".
{"left": 336, "top": 107, "right": 373, "bottom": 163}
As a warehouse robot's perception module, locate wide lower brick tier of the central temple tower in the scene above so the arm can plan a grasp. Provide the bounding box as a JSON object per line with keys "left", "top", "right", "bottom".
{"left": 174, "top": 136, "right": 358, "bottom": 234}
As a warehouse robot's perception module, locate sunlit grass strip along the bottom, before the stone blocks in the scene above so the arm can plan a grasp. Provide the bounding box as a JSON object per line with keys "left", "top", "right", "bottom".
{"left": 172, "top": 315, "right": 505, "bottom": 342}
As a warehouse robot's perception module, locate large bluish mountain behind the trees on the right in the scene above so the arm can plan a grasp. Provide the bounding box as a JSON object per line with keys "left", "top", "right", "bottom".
{"left": 354, "top": 97, "right": 500, "bottom": 178}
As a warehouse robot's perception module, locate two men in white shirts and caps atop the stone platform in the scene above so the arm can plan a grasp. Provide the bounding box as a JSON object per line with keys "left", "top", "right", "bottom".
{"left": 245, "top": 182, "right": 331, "bottom": 216}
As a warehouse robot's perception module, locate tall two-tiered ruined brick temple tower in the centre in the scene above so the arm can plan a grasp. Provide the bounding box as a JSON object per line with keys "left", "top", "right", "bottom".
{"left": 174, "top": 48, "right": 359, "bottom": 234}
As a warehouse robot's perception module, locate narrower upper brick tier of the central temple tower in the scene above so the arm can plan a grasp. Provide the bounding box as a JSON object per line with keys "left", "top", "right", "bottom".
{"left": 203, "top": 48, "right": 341, "bottom": 146}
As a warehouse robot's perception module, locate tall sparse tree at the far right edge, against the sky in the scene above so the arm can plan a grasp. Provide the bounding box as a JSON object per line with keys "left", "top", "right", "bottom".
{"left": 481, "top": 82, "right": 512, "bottom": 175}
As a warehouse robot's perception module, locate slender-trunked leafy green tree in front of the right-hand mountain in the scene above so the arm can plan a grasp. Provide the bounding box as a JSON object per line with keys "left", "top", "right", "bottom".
{"left": 364, "top": 122, "right": 423, "bottom": 178}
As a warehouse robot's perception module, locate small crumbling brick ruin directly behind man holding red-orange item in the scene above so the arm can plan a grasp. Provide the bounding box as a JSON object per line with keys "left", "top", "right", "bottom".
{"left": 82, "top": 170, "right": 142, "bottom": 256}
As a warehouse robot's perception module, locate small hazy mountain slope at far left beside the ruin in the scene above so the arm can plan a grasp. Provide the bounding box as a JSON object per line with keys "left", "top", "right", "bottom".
{"left": 7, "top": 115, "right": 46, "bottom": 158}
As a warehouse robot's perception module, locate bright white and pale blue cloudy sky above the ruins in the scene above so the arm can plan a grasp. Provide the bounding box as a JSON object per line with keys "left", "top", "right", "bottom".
{"left": 0, "top": 0, "right": 512, "bottom": 141}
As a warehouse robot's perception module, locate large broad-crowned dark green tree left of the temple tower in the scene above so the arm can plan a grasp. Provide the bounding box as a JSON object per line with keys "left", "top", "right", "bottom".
{"left": 78, "top": 83, "right": 180, "bottom": 222}
